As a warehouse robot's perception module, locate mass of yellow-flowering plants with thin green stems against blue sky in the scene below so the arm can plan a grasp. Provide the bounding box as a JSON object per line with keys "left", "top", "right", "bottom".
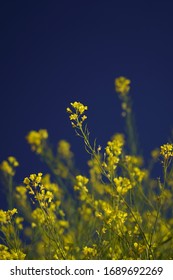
{"left": 0, "top": 77, "right": 173, "bottom": 260}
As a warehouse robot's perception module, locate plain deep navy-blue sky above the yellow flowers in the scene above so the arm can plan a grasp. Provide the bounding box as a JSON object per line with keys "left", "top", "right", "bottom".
{"left": 0, "top": 0, "right": 173, "bottom": 190}
